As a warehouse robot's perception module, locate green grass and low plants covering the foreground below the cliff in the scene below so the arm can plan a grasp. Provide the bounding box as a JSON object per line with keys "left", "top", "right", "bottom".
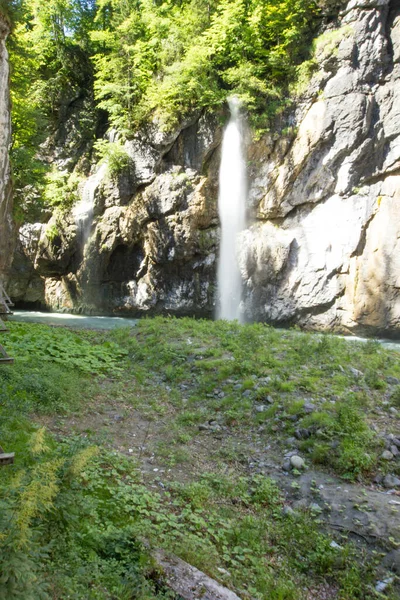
{"left": 0, "top": 318, "right": 400, "bottom": 600}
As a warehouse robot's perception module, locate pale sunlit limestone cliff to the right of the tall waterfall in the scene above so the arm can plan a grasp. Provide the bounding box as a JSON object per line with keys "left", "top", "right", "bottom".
{"left": 241, "top": 0, "right": 400, "bottom": 333}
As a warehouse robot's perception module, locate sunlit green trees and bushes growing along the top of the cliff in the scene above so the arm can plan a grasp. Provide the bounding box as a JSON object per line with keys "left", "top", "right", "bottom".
{"left": 6, "top": 0, "right": 320, "bottom": 221}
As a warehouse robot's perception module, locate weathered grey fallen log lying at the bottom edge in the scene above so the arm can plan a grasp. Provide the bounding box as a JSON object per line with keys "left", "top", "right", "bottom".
{"left": 153, "top": 550, "right": 240, "bottom": 600}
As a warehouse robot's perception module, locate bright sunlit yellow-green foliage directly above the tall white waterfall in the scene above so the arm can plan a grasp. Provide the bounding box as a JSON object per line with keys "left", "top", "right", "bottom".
{"left": 91, "top": 0, "right": 319, "bottom": 132}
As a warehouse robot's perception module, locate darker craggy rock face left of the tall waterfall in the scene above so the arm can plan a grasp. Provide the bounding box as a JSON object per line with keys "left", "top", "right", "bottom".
{"left": 10, "top": 115, "right": 220, "bottom": 316}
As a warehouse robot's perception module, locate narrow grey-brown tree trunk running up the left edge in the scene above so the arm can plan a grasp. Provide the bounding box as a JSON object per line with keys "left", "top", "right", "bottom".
{"left": 0, "top": 14, "right": 14, "bottom": 280}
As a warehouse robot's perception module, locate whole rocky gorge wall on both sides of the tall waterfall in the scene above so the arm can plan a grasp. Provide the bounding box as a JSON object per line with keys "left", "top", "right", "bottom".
{"left": 11, "top": 0, "right": 400, "bottom": 334}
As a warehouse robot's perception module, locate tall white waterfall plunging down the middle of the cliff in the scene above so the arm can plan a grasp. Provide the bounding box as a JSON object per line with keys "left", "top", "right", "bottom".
{"left": 217, "top": 97, "right": 247, "bottom": 321}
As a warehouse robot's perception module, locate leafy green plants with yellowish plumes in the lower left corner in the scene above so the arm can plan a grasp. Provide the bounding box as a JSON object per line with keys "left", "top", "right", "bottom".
{"left": 0, "top": 419, "right": 171, "bottom": 600}
